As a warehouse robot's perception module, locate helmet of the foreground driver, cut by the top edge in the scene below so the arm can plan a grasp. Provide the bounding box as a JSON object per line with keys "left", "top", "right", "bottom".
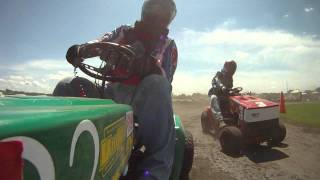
{"left": 141, "top": 0, "right": 177, "bottom": 27}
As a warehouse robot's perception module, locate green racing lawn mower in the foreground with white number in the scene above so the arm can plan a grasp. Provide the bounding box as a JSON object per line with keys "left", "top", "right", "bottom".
{"left": 0, "top": 42, "right": 193, "bottom": 180}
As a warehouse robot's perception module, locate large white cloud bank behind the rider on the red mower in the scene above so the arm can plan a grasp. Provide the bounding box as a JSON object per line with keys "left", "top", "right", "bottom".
{"left": 173, "top": 25, "right": 320, "bottom": 94}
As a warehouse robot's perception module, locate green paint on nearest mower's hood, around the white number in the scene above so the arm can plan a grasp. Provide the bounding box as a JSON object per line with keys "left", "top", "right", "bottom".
{"left": 0, "top": 97, "right": 133, "bottom": 180}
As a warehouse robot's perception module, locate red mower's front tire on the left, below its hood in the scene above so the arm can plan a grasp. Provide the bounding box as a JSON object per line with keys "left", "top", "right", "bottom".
{"left": 219, "top": 126, "right": 243, "bottom": 155}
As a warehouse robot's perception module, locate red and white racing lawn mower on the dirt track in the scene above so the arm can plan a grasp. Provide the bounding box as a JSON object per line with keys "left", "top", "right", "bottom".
{"left": 201, "top": 87, "right": 286, "bottom": 154}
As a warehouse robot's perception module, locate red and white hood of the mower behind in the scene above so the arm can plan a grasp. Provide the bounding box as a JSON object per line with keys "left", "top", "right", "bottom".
{"left": 230, "top": 95, "right": 280, "bottom": 123}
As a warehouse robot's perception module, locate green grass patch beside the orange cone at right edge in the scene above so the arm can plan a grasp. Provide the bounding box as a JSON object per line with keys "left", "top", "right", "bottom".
{"left": 280, "top": 101, "right": 320, "bottom": 128}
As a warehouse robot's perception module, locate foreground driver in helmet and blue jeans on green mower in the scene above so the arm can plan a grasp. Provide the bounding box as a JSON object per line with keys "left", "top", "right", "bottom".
{"left": 53, "top": 0, "right": 178, "bottom": 180}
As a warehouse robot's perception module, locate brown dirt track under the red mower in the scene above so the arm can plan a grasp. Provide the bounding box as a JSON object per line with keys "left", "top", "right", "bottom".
{"left": 173, "top": 97, "right": 320, "bottom": 180}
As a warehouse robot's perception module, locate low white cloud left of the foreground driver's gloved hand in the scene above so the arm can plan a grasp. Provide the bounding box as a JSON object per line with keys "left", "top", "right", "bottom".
{"left": 0, "top": 59, "right": 73, "bottom": 93}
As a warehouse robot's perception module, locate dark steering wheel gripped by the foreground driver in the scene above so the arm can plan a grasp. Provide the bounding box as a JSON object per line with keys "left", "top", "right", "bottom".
{"left": 79, "top": 42, "right": 136, "bottom": 81}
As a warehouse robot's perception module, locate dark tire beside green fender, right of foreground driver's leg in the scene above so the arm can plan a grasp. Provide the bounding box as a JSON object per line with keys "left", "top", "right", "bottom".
{"left": 179, "top": 131, "right": 194, "bottom": 180}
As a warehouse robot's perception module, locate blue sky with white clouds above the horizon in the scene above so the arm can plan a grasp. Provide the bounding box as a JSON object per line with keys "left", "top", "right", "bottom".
{"left": 0, "top": 0, "right": 320, "bottom": 94}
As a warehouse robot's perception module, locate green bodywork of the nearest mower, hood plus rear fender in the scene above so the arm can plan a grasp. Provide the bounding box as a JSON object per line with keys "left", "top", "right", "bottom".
{"left": 0, "top": 96, "right": 185, "bottom": 180}
